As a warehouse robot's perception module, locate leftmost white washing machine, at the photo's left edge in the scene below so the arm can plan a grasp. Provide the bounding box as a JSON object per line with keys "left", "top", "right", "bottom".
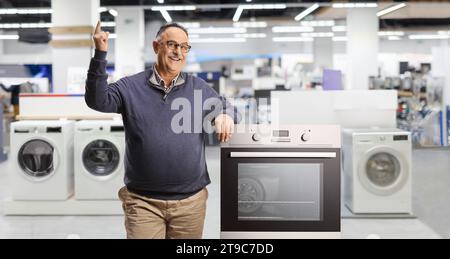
{"left": 10, "top": 121, "right": 74, "bottom": 200}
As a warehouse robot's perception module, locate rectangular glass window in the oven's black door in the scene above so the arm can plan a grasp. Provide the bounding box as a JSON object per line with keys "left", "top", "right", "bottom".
{"left": 237, "top": 163, "right": 322, "bottom": 221}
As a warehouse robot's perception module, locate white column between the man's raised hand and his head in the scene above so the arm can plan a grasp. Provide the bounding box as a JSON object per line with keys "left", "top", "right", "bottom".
{"left": 114, "top": 8, "right": 145, "bottom": 78}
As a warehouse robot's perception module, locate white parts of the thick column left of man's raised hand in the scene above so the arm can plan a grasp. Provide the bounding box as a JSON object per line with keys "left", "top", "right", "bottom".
{"left": 52, "top": 0, "right": 100, "bottom": 93}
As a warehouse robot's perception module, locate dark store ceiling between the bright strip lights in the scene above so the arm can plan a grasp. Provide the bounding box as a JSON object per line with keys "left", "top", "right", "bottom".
{"left": 0, "top": 0, "right": 450, "bottom": 29}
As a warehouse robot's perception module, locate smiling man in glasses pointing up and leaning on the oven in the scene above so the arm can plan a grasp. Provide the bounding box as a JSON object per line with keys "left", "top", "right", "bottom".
{"left": 85, "top": 22, "right": 239, "bottom": 239}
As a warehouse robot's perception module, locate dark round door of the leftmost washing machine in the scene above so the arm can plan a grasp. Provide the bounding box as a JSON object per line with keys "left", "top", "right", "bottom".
{"left": 18, "top": 139, "right": 55, "bottom": 180}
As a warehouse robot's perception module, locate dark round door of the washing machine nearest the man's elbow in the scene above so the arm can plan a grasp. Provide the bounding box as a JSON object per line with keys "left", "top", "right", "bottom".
{"left": 83, "top": 139, "right": 120, "bottom": 177}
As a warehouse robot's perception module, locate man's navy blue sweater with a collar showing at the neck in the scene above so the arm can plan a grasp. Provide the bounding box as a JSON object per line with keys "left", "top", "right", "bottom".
{"left": 85, "top": 51, "right": 240, "bottom": 200}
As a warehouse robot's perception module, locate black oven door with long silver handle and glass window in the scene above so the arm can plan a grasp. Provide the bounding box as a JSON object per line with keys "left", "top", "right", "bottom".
{"left": 221, "top": 148, "right": 341, "bottom": 232}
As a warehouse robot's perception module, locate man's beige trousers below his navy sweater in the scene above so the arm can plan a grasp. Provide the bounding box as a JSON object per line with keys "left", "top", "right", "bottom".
{"left": 119, "top": 187, "right": 208, "bottom": 239}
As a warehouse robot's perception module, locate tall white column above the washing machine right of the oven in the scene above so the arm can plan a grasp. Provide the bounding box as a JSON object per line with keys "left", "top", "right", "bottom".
{"left": 347, "top": 8, "right": 379, "bottom": 90}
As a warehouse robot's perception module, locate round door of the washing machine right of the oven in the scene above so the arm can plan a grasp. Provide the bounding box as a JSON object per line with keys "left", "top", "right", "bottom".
{"left": 358, "top": 147, "right": 409, "bottom": 196}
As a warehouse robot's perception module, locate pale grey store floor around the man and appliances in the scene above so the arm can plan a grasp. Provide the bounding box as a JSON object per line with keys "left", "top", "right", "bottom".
{"left": 0, "top": 148, "right": 450, "bottom": 239}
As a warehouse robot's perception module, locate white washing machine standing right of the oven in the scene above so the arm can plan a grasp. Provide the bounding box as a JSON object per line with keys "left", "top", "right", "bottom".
{"left": 343, "top": 129, "right": 412, "bottom": 214}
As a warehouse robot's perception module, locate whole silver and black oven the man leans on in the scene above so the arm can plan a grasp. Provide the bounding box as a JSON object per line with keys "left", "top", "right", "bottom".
{"left": 221, "top": 124, "right": 341, "bottom": 239}
